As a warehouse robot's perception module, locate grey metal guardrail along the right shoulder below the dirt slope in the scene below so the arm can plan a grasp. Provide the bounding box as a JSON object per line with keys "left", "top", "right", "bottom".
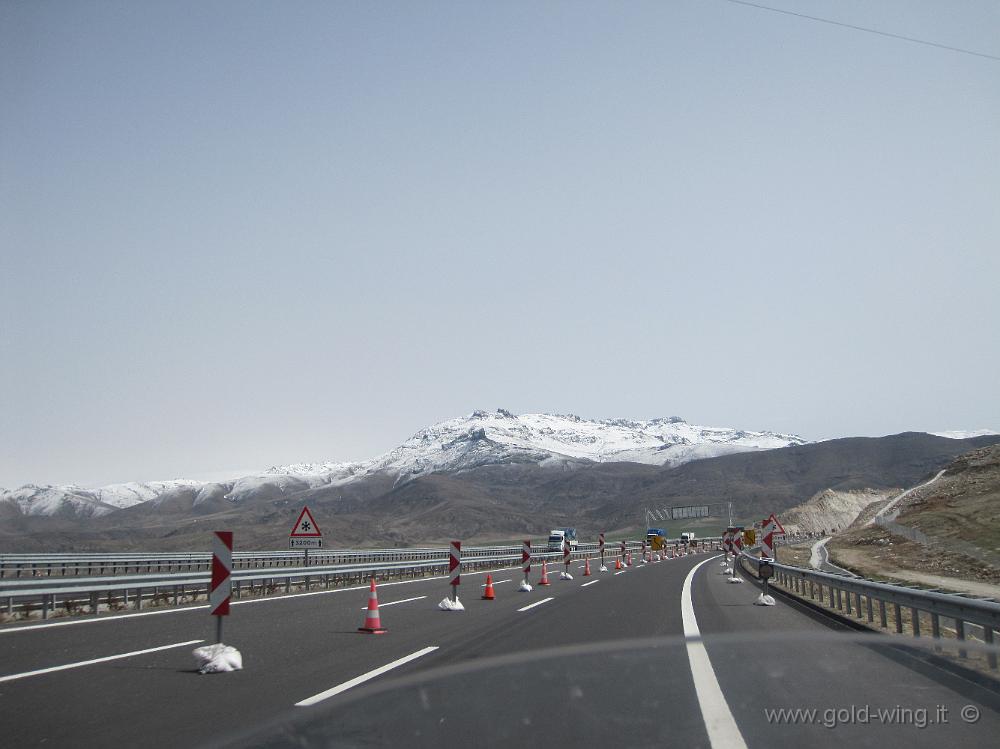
{"left": 740, "top": 552, "right": 1000, "bottom": 670}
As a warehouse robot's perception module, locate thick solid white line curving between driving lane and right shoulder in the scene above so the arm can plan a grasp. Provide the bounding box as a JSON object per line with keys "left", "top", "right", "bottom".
{"left": 681, "top": 556, "right": 747, "bottom": 749}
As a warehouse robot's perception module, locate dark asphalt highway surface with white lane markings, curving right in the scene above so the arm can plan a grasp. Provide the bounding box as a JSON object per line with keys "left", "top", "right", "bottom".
{"left": 0, "top": 554, "right": 1000, "bottom": 749}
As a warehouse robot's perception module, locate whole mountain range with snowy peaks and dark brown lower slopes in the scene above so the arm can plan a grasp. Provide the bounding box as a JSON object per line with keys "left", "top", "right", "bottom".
{"left": 0, "top": 410, "right": 1000, "bottom": 551}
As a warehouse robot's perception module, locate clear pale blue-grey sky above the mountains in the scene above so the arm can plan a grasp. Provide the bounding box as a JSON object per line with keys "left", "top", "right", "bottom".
{"left": 0, "top": 0, "right": 1000, "bottom": 488}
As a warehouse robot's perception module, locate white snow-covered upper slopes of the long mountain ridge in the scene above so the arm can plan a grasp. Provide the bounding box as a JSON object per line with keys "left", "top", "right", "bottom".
{"left": 0, "top": 409, "right": 806, "bottom": 516}
